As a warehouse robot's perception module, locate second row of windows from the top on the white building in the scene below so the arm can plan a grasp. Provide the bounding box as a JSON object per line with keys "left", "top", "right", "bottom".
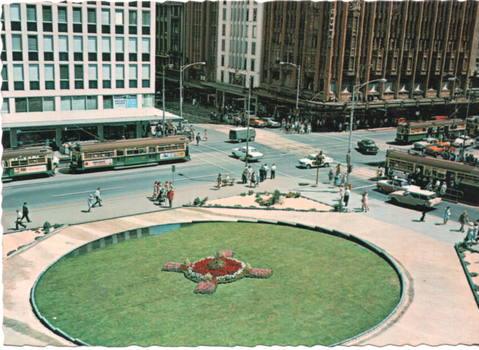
{"left": 1, "top": 34, "right": 151, "bottom": 62}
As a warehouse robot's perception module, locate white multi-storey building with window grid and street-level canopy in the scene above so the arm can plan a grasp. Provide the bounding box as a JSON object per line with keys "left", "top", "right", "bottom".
{"left": 1, "top": 1, "right": 161, "bottom": 147}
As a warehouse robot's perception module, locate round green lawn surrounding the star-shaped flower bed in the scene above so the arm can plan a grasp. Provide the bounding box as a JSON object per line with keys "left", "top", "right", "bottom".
{"left": 36, "top": 223, "right": 400, "bottom": 347}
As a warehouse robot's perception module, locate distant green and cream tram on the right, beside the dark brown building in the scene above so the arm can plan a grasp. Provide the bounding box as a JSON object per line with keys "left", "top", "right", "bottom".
{"left": 396, "top": 119, "right": 466, "bottom": 143}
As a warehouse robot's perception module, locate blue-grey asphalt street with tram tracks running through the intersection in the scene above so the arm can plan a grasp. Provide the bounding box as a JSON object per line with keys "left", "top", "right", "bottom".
{"left": 2, "top": 124, "right": 479, "bottom": 243}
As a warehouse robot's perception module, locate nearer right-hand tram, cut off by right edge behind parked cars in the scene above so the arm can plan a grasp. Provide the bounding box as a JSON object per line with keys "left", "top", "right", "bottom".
{"left": 386, "top": 149, "right": 479, "bottom": 205}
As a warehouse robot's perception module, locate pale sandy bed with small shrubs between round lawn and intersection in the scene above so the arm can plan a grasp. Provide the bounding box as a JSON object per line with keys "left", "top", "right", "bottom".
{"left": 205, "top": 194, "right": 332, "bottom": 211}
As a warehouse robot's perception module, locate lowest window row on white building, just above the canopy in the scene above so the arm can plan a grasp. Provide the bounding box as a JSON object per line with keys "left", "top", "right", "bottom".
{"left": 1, "top": 94, "right": 155, "bottom": 113}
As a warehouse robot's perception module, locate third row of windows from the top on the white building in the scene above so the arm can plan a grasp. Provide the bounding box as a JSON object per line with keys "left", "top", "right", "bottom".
{"left": 1, "top": 64, "right": 151, "bottom": 91}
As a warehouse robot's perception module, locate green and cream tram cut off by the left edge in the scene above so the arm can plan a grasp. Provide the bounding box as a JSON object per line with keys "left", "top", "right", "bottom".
{"left": 2, "top": 147, "right": 55, "bottom": 182}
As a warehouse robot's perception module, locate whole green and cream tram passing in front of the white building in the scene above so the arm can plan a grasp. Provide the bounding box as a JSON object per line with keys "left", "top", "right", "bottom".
{"left": 66, "top": 136, "right": 190, "bottom": 173}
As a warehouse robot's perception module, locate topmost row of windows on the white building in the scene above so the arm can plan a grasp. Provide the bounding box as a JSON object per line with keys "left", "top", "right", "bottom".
{"left": 2, "top": 4, "right": 151, "bottom": 35}
